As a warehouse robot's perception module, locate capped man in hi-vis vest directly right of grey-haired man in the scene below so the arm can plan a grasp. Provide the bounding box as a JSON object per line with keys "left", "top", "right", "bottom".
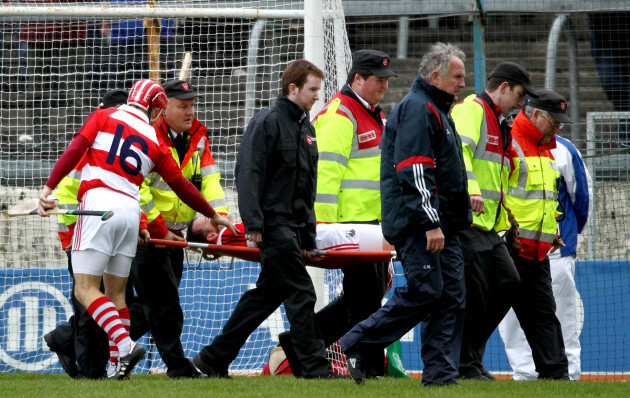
{"left": 451, "top": 62, "right": 535, "bottom": 380}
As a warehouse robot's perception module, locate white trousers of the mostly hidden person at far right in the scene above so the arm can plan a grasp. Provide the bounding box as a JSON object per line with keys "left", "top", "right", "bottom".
{"left": 499, "top": 256, "right": 584, "bottom": 380}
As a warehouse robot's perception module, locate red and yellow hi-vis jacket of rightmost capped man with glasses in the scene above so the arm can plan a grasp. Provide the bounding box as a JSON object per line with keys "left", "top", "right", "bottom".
{"left": 507, "top": 110, "right": 560, "bottom": 261}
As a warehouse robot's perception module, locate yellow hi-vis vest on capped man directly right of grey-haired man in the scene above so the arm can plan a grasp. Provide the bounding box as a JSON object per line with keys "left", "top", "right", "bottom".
{"left": 451, "top": 94, "right": 511, "bottom": 232}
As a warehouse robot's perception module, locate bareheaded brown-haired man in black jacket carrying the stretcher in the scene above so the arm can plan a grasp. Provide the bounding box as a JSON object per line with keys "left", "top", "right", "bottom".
{"left": 193, "top": 60, "right": 332, "bottom": 378}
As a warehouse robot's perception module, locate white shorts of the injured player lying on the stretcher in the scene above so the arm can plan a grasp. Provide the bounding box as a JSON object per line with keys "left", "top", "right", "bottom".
{"left": 315, "top": 224, "right": 383, "bottom": 251}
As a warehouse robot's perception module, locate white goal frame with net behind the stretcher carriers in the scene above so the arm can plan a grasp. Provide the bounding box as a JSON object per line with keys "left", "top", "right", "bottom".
{"left": 0, "top": 0, "right": 351, "bottom": 373}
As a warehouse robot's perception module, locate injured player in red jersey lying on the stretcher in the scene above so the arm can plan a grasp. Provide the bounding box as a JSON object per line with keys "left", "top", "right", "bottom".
{"left": 186, "top": 217, "right": 394, "bottom": 251}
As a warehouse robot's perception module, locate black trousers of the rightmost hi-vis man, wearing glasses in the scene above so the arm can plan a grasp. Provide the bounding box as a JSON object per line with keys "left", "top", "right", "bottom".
{"left": 513, "top": 257, "right": 569, "bottom": 379}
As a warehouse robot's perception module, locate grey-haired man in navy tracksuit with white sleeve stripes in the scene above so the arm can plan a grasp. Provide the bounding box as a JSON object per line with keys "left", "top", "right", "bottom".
{"left": 341, "top": 43, "right": 472, "bottom": 385}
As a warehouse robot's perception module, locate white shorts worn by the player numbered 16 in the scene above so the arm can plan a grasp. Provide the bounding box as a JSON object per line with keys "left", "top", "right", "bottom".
{"left": 72, "top": 188, "right": 140, "bottom": 258}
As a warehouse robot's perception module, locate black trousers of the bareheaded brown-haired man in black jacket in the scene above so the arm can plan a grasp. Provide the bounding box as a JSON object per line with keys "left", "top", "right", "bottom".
{"left": 199, "top": 225, "right": 332, "bottom": 378}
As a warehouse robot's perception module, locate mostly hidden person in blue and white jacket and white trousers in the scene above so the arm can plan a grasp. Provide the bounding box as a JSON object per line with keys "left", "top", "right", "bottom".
{"left": 504, "top": 135, "right": 593, "bottom": 380}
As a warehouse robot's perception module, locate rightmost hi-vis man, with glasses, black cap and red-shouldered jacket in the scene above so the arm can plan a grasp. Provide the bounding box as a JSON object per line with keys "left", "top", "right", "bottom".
{"left": 506, "top": 90, "right": 571, "bottom": 379}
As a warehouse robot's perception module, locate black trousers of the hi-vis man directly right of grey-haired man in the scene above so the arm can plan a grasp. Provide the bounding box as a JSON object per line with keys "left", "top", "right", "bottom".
{"left": 459, "top": 228, "right": 520, "bottom": 377}
